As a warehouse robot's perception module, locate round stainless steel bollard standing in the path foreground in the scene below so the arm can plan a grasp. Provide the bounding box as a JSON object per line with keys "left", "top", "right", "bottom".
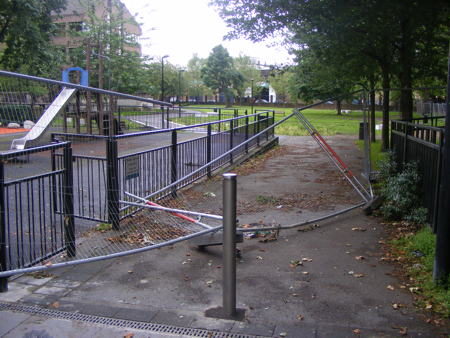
{"left": 223, "top": 173, "right": 237, "bottom": 317}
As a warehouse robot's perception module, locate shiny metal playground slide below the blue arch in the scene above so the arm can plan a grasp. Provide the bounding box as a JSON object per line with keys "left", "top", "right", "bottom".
{"left": 11, "top": 88, "right": 76, "bottom": 150}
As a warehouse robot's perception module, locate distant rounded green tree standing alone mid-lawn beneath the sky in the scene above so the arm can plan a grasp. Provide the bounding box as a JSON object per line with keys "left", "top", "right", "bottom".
{"left": 201, "top": 45, "right": 244, "bottom": 107}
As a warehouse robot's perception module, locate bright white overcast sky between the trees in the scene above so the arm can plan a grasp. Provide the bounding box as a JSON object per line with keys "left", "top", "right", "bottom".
{"left": 122, "top": 0, "right": 291, "bottom": 66}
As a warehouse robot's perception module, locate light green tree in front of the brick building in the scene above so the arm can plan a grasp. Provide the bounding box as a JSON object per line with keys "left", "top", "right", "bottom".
{"left": 67, "top": 0, "right": 149, "bottom": 94}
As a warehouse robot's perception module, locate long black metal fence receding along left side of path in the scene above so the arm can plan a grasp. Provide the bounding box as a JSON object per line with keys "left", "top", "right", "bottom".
{"left": 53, "top": 112, "right": 274, "bottom": 226}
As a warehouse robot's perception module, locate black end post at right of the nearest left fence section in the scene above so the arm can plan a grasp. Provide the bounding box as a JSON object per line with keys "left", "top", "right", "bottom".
{"left": 63, "top": 144, "right": 76, "bottom": 257}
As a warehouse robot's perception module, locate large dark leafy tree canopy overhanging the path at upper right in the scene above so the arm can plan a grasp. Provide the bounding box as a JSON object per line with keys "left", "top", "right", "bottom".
{"left": 213, "top": 0, "right": 450, "bottom": 148}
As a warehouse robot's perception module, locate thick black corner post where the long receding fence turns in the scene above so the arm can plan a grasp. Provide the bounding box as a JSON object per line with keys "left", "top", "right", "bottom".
{"left": 106, "top": 137, "right": 119, "bottom": 230}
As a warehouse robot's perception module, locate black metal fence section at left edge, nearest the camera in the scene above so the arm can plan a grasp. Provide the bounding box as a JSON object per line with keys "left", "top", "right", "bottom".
{"left": 0, "top": 142, "right": 75, "bottom": 286}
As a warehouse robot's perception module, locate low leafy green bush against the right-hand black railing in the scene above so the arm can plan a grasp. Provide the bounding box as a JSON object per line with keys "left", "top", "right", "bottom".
{"left": 380, "top": 154, "right": 427, "bottom": 224}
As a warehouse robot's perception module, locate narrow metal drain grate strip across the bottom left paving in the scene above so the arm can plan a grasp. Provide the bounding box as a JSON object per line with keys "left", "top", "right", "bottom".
{"left": 0, "top": 302, "right": 268, "bottom": 338}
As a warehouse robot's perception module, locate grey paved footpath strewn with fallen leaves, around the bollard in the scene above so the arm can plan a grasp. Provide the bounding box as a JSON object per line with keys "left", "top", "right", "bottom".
{"left": 0, "top": 136, "right": 448, "bottom": 338}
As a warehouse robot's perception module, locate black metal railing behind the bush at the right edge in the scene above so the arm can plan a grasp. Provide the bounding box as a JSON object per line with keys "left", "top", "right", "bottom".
{"left": 391, "top": 118, "right": 444, "bottom": 226}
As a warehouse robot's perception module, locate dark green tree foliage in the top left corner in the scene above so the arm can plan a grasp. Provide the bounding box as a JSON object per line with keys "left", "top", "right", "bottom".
{"left": 0, "top": 0, "right": 66, "bottom": 75}
